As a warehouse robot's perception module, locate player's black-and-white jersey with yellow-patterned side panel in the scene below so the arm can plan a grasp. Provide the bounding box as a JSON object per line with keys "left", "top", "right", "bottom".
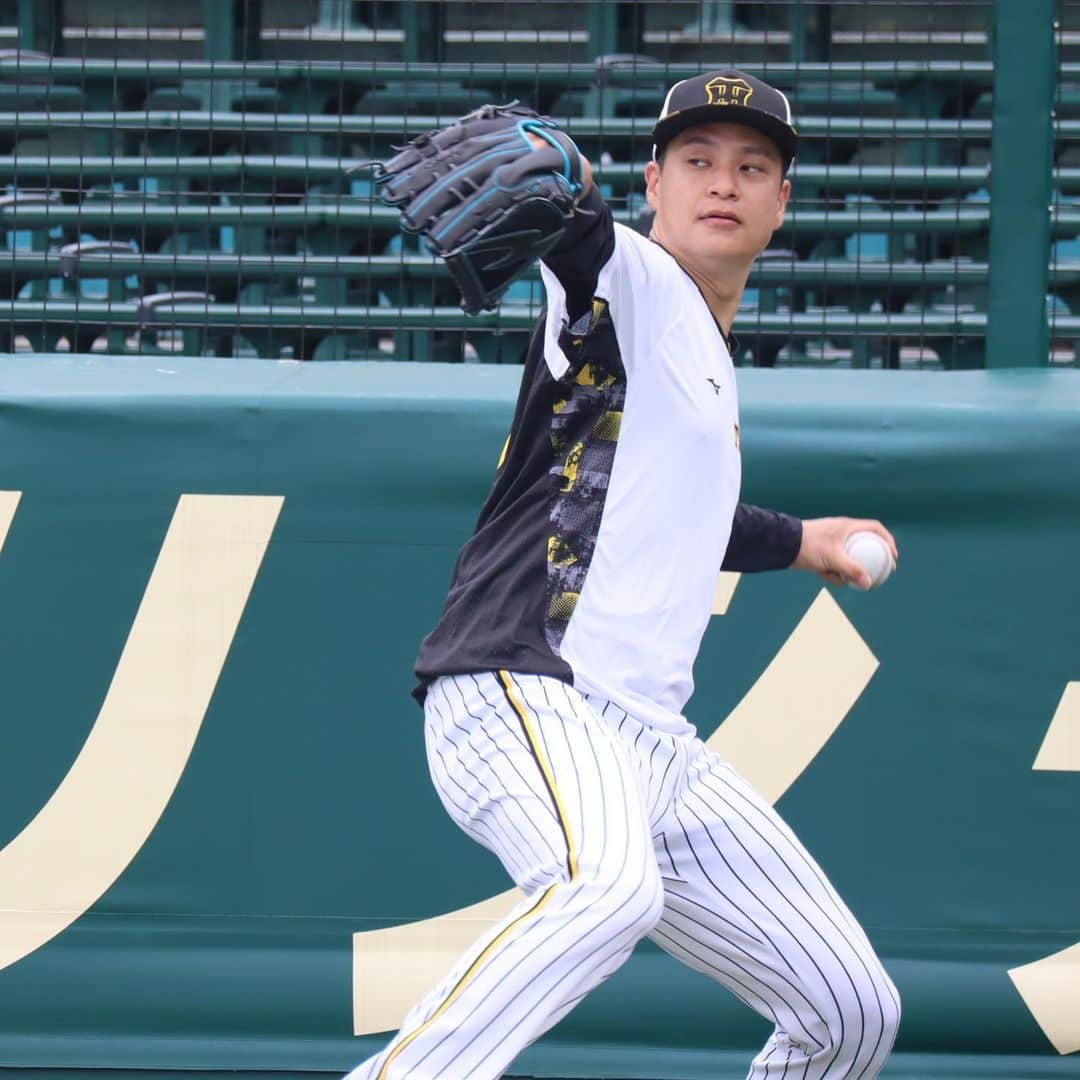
{"left": 417, "top": 197, "right": 797, "bottom": 732}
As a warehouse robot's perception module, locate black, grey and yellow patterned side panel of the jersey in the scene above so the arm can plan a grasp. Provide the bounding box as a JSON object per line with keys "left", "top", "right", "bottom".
{"left": 544, "top": 299, "right": 626, "bottom": 652}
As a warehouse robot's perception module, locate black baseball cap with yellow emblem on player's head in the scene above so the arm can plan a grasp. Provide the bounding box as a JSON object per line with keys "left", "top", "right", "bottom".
{"left": 652, "top": 68, "right": 798, "bottom": 173}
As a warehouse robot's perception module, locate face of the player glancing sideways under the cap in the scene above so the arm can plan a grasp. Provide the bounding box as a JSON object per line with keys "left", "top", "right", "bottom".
{"left": 645, "top": 122, "right": 792, "bottom": 269}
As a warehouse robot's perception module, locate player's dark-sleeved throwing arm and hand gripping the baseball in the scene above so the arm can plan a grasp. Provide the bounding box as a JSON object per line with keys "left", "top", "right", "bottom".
{"left": 721, "top": 502, "right": 900, "bottom": 589}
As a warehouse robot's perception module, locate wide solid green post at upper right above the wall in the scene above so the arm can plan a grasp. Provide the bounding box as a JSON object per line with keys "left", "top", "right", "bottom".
{"left": 986, "top": 0, "right": 1057, "bottom": 367}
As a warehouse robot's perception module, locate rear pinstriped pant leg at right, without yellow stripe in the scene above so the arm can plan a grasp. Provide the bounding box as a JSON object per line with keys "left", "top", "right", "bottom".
{"left": 652, "top": 743, "right": 900, "bottom": 1080}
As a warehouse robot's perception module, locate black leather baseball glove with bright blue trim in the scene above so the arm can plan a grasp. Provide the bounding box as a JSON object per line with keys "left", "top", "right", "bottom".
{"left": 376, "top": 104, "right": 582, "bottom": 315}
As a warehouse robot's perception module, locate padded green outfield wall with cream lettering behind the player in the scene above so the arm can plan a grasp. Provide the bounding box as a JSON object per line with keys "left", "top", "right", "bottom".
{"left": 0, "top": 355, "right": 1080, "bottom": 1080}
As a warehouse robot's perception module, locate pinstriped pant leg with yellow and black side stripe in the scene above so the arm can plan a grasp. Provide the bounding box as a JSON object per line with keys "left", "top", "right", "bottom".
{"left": 349, "top": 672, "right": 663, "bottom": 1080}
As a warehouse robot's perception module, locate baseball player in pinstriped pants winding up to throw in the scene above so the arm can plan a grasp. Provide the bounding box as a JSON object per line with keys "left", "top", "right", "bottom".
{"left": 350, "top": 70, "right": 900, "bottom": 1080}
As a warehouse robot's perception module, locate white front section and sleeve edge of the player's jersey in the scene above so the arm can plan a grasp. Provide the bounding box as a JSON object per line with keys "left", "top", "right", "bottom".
{"left": 543, "top": 225, "right": 741, "bottom": 730}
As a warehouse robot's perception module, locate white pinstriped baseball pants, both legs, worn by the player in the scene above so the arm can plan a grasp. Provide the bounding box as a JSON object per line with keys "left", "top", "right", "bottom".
{"left": 348, "top": 672, "right": 900, "bottom": 1080}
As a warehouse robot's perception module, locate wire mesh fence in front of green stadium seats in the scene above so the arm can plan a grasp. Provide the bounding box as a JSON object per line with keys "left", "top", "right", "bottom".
{"left": 0, "top": 0, "right": 1080, "bottom": 368}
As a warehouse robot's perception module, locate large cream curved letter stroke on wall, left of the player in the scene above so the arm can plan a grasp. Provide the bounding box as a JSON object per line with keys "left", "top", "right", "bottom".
{"left": 0, "top": 495, "right": 283, "bottom": 969}
